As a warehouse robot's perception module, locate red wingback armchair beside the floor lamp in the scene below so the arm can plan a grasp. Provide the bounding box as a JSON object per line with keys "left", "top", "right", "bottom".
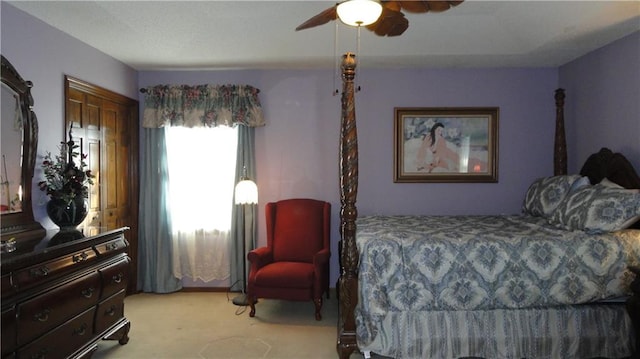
{"left": 247, "top": 198, "right": 331, "bottom": 320}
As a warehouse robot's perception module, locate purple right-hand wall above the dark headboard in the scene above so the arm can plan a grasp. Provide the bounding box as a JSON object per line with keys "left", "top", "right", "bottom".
{"left": 559, "top": 31, "right": 640, "bottom": 172}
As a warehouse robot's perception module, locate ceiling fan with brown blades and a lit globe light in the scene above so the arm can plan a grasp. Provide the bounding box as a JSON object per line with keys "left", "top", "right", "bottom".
{"left": 296, "top": 0, "right": 464, "bottom": 36}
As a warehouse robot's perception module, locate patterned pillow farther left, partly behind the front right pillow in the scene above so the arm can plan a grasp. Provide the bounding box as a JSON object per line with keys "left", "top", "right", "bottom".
{"left": 522, "top": 175, "right": 582, "bottom": 218}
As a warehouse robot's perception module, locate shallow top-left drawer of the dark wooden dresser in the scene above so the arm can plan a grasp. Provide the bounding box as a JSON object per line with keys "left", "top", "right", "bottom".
{"left": 12, "top": 248, "right": 97, "bottom": 290}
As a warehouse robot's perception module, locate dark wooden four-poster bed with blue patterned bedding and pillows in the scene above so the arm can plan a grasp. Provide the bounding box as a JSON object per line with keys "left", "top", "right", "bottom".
{"left": 337, "top": 53, "right": 640, "bottom": 359}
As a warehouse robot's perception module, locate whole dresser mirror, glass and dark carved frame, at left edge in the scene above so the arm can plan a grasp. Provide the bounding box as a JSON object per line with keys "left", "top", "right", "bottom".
{"left": 0, "top": 56, "right": 42, "bottom": 235}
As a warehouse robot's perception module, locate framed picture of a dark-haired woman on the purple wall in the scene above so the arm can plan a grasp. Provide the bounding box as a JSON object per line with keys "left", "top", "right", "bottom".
{"left": 393, "top": 107, "right": 499, "bottom": 182}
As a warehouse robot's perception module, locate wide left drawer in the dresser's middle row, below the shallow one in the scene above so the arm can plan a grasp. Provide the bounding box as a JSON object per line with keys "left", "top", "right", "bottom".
{"left": 18, "top": 271, "right": 100, "bottom": 345}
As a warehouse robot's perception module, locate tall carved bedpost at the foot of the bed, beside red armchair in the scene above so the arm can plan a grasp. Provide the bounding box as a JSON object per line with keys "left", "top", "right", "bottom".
{"left": 337, "top": 52, "right": 358, "bottom": 359}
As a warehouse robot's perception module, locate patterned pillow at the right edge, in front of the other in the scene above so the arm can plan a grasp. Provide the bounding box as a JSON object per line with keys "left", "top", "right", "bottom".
{"left": 549, "top": 184, "right": 640, "bottom": 233}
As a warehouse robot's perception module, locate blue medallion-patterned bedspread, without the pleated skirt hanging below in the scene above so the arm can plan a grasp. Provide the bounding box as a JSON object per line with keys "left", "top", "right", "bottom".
{"left": 356, "top": 216, "right": 640, "bottom": 315}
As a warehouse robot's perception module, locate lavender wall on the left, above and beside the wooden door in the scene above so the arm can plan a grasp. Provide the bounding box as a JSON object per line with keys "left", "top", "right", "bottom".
{"left": 0, "top": 1, "right": 138, "bottom": 228}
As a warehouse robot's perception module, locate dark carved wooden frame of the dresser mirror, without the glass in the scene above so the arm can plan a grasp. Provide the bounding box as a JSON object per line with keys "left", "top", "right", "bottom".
{"left": 0, "top": 55, "right": 42, "bottom": 235}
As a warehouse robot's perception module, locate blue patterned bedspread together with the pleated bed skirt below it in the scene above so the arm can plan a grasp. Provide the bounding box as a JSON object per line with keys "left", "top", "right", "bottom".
{"left": 356, "top": 216, "right": 640, "bottom": 359}
